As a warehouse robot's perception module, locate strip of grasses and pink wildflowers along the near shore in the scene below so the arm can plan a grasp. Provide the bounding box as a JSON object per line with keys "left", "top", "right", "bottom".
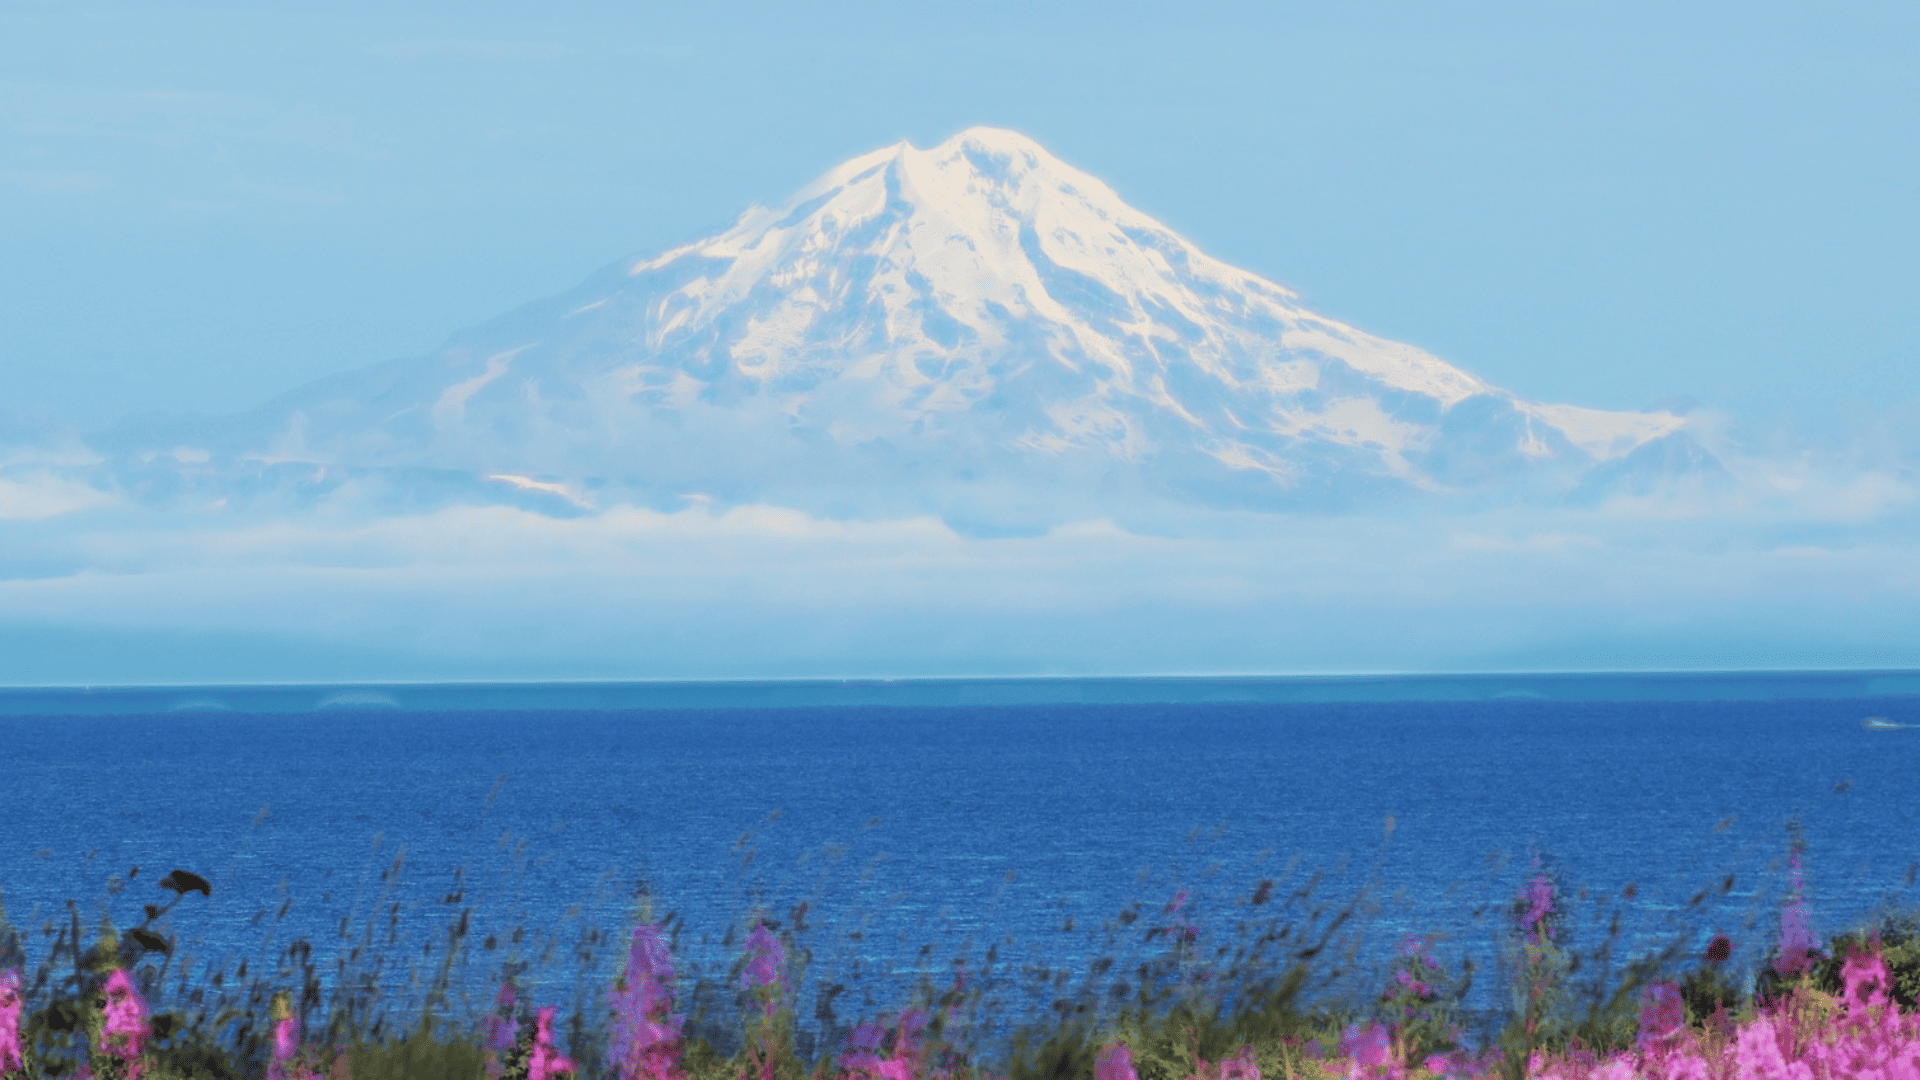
{"left": 0, "top": 810, "right": 1920, "bottom": 1080}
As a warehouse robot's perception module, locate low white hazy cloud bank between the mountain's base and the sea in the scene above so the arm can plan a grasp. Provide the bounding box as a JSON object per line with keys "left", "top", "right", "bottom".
{"left": 0, "top": 447, "right": 1920, "bottom": 684}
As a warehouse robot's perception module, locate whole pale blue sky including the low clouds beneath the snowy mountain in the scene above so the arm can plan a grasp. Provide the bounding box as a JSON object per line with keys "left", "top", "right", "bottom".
{"left": 0, "top": 0, "right": 1920, "bottom": 682}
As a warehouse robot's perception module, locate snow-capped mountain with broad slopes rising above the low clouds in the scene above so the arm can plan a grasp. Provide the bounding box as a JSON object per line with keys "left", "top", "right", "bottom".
{"left": 96, "top": 127, "right": 1699, "bottom": 517}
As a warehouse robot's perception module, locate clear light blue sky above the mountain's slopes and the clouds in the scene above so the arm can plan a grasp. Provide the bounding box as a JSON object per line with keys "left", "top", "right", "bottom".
{"left": 0, "top": 2, "right": 1920, "bottom": 434}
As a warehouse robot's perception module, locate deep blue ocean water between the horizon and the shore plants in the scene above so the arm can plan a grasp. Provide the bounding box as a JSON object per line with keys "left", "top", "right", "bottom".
{"left": 0, "top": 673, "right": 1920, "bottom": 1060}
